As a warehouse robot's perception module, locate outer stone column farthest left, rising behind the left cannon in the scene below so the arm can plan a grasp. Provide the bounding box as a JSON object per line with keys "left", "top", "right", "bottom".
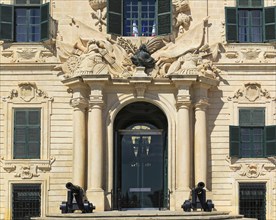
{"left": 71, "top": 97, "right": 88, "bottom": 188}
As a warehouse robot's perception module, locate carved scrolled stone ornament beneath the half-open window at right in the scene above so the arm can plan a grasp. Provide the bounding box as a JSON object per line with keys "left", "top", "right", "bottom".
{"left": 226, "top": 156, "right": 276, "bottom": 178}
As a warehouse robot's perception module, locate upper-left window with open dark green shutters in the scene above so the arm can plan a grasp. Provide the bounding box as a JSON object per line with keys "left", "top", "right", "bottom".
{"left": 0, "top": 0, "right": 49, "bottom": 42}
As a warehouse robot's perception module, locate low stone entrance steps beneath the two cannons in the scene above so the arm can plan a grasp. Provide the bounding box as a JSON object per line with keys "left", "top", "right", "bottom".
{"left": 32, "top": 210, "right": 253, "bottom": 220}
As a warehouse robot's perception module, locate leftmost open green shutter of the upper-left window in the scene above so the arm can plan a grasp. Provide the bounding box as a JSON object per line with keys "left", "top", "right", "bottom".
{"left": 0, "top": 4, "right": 14, "bottom": 41}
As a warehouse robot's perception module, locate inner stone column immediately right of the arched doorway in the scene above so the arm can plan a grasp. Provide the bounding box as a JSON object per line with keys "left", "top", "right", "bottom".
{"left": 172, "top": 76, "right": 196, "bottom": 210}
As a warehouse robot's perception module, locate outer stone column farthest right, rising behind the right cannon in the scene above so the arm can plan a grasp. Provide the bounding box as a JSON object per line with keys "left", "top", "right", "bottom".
{"left": 194, "top": 99, "right": 209, "bottom": 186}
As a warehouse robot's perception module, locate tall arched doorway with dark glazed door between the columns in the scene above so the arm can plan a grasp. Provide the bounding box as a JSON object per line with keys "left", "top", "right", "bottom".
{"left": 113, "top": 102, "right": 168, "bottom": 210}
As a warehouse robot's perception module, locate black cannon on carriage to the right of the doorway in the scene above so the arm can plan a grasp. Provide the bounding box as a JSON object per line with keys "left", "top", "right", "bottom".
{"left": 181, "top": 182, "right": 215, "bottom": 212}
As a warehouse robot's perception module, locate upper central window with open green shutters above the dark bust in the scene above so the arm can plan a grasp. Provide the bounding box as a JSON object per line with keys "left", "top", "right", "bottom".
{"left": 107, "top": 0, "right": 172, "bottom": 37}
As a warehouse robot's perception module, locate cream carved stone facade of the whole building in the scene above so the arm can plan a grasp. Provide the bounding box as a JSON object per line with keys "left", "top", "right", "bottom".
{"left": 0, "top": 0, "right": 276, "bottom": 219}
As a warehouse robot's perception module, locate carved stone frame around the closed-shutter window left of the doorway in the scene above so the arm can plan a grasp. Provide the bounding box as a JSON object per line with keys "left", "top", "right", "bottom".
{"left": 3, "top": 82, "right": 53, "bottom": 163}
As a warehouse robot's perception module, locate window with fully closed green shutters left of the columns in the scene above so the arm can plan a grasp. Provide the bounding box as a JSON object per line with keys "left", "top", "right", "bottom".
{"left": 13, "top": 109, "right": 41, "bottom": 159}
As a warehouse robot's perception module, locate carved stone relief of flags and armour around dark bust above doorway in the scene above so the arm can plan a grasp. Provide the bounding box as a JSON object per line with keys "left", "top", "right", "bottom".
{"left": 52, "top": 0, "right": 222, "bottom": 79}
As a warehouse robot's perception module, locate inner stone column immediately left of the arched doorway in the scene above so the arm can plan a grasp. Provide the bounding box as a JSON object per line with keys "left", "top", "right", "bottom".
{"left": 85, "top": 76, "right": 109, "bottom": 211}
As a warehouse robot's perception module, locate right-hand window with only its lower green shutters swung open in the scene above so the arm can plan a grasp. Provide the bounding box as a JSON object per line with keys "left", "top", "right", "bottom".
{"left": 229, "top": 108, "right": 276, "bottom": 158}
